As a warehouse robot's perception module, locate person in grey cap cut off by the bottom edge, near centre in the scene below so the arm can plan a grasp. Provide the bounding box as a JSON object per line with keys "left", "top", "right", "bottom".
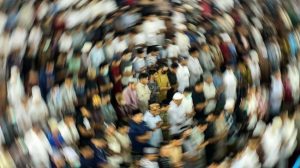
{"left": 140, "top": 147, "right": 159, "bottom": 168}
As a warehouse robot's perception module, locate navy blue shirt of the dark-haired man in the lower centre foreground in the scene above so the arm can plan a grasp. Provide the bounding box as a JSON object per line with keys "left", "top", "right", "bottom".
{"left": 128, "top": 121, "right": 151, "bottom": 154}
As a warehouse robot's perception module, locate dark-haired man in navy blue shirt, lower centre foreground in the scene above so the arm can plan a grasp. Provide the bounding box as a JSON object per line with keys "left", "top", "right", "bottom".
{"left": 128, "top": 110, "right": 152, "bottom": 162}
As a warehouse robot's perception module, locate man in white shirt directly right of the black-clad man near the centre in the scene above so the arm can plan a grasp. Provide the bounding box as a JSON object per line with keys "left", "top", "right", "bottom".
{"left": 176, "top": 57, "right": 190, "bottom": 92}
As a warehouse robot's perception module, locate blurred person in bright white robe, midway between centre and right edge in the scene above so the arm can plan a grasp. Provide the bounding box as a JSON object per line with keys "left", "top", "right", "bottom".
{"left": 223, "top": 65, "right": 237, "bottom": 99}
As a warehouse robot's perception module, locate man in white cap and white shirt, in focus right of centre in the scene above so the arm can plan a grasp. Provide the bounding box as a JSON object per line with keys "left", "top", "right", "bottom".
{"left": 168, "top": 92, "right": 187, "bottom": 135}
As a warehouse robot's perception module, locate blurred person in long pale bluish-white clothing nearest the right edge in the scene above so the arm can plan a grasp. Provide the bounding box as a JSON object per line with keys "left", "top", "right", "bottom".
{"left": 269, "top": 71, "right": 284, "bottom": 121}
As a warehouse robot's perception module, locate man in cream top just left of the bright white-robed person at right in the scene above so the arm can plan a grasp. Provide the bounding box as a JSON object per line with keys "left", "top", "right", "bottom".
{"left": 203, "top": 73, "right": 216, "bottom": 115}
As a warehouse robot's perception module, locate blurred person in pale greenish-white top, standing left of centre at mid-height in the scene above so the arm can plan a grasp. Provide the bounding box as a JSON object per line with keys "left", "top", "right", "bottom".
{"left": 60, "top": 74, "right": 77, "bottom": 113}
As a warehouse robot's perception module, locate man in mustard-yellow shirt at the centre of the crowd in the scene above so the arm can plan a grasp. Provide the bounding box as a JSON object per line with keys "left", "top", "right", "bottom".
{"left": 156, "top": 64, "right": 170, "bottom": 102}
